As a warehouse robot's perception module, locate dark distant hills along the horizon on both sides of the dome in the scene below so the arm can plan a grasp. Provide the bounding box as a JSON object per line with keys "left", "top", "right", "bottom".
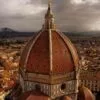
{"left": 0, "top": 27, "right": 100, "bottom": 38}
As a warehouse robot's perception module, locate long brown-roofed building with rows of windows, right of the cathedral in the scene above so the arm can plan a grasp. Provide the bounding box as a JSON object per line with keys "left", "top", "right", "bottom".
{"left": 80, "top": 70, "right": 100, "bottom": 100}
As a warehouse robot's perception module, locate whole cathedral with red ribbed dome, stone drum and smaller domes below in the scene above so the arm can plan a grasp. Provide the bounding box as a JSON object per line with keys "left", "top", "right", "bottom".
{"left": 18, "top": 1, "right": 95, "bottom": 100}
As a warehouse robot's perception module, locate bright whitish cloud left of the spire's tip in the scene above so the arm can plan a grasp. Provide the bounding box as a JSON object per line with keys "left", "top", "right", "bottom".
{"left": 0, "top": 0, "right": 46, "bottom": 16}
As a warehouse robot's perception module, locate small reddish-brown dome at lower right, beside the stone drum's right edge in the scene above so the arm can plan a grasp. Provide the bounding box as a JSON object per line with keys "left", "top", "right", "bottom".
{"left": 78, "top": 86, "right": 95, "bottom": 100}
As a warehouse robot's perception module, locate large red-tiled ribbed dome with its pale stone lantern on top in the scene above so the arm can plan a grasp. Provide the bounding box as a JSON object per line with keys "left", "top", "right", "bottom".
{"left": 20, "top": 0, "right": 79, "bottom": 74}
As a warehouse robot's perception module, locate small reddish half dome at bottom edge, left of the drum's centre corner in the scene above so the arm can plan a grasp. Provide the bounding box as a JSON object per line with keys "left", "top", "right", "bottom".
{"left": 19, "top": 91, "right": 51, "bottom": 100}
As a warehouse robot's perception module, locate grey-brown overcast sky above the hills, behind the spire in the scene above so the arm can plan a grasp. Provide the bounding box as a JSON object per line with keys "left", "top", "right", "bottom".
{"left": 0, "top": 0, "right": 100, "bottom": 31}
